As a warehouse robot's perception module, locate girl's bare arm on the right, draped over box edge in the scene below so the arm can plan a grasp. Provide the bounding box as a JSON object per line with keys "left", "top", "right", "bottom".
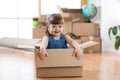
{"left": 65, "top": 35, "right": 82, "bottom": 60}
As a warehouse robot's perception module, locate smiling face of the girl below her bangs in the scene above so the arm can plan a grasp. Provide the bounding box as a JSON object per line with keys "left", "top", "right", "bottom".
{"left": 48, "top": 24, "right": 63, "bottom": 37}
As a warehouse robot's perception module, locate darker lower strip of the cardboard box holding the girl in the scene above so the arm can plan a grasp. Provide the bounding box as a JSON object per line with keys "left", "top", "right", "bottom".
{"left": 37, "top": 67, "right": 83, "bottom": 77}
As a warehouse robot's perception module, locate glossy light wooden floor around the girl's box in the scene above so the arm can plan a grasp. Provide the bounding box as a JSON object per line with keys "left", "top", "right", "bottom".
{"left": 0, "top": 49, "right": 120, "bottom": 80}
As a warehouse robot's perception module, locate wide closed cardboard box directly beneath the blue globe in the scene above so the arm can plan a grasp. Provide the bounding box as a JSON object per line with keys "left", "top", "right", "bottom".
{"left": 72, "top": 23, "right": 100, "bottom": 36}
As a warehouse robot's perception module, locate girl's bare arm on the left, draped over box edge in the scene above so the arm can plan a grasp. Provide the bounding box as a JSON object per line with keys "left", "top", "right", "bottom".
{"left": 39, "top": 36, "right": 48, "bottom": 60}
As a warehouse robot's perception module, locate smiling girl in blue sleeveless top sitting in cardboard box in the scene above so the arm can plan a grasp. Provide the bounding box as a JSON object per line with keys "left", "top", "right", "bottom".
{"left": 39, "top": 14, "right": 82, "bottom": 60}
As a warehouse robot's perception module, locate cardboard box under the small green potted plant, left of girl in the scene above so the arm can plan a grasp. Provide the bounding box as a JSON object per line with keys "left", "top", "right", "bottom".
{"left": 33, "top": 28, "right": 45, "bottom": 39}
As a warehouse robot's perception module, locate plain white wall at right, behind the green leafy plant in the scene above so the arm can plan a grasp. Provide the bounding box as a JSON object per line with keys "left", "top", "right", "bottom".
{"left": 101, "top": 0, "right": 120, "bottom": 52}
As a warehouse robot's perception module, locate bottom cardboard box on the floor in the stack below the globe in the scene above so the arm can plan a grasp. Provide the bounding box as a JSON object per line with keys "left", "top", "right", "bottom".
{"left": 81, "top": 36, "right": 101, "bottom": 53}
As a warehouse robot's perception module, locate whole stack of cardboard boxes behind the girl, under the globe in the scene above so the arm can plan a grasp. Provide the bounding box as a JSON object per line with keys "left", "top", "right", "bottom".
{"left": 59, "top": 8, "right": 101, "bottom": 53}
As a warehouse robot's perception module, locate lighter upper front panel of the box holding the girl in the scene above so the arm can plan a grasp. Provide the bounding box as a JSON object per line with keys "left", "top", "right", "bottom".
{"left": 36, "top": 49, "right": 83, "bottom": 68}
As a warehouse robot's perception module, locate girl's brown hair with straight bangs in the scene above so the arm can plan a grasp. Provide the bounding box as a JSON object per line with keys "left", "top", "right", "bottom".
{"left": 46, "top": 14, "right": 64, "bottom": 36}
